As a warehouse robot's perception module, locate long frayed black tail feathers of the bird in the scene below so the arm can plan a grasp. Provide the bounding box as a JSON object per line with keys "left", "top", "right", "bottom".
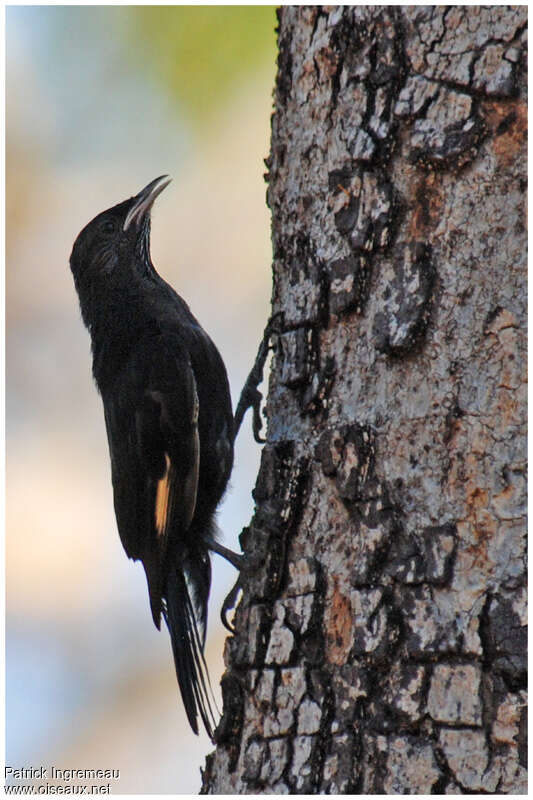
{"left": 163, "top": 552, "right": 216, "bottom": 739}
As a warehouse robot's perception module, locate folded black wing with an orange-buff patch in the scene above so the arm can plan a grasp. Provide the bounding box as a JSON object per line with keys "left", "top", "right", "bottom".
{"left": 103, "top": 338, "right": 200, "bottom": 627}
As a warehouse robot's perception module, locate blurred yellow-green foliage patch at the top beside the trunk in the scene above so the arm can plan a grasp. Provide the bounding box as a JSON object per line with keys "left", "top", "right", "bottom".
{"left": 130, "top": 6, "right": 277, "bottom": 123}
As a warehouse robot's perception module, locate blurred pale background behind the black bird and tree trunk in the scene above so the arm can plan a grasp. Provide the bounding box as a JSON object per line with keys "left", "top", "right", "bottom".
{"left": 6, "top": 6, "right": 276, "bottom": 794}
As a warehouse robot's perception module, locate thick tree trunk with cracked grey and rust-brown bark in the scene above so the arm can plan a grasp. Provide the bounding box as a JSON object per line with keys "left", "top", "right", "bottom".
{"left": 203, "top": 6, "right": 527, "bottom": 794}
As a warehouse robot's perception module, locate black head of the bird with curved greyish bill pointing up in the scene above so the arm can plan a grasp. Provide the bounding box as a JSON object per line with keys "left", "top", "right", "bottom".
{"left": 70, "top": 175, "right": 171, "bottom": 291}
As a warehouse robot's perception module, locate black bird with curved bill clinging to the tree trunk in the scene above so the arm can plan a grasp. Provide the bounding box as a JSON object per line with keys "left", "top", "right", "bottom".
{"left": 70, "top": 175, "right": 240, "bottom": 737}
